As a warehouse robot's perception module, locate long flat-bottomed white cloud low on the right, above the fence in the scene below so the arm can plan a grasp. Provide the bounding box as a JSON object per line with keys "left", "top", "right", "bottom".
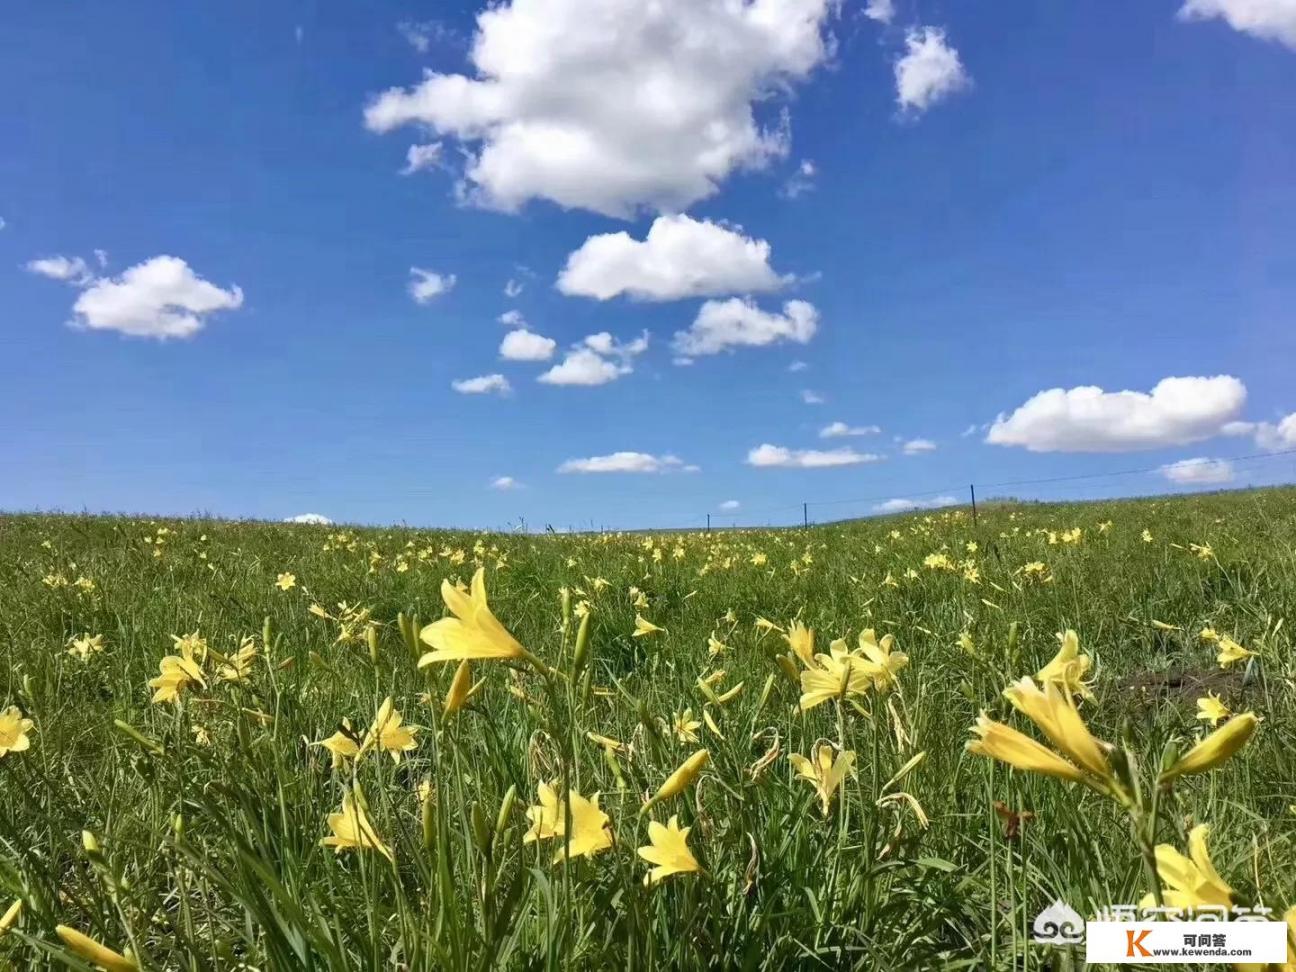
{"left": 985, "top": 375, "right": 1247, "bottom": 452}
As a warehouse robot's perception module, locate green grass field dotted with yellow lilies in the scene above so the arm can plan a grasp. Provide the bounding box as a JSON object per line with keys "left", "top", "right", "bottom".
{"left": 0, "top": 490, "right": 1296, "bottom": 971}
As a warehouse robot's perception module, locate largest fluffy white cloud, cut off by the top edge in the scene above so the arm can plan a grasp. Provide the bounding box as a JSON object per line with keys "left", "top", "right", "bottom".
{"left": 364, "top": 0, "right": 837, "bottom": 216}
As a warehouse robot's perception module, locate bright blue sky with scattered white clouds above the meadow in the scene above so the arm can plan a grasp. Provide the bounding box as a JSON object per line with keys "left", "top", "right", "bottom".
{"left": 0, "top": 0, "right": 1296, "bottom": 527}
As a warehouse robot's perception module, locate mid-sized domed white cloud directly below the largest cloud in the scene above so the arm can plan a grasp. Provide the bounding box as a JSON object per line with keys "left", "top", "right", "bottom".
{"left": 557, "top": 213, "right": 789, "bottom": 301}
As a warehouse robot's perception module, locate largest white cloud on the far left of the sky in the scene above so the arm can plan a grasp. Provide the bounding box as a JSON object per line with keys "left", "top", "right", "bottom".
{"left": 67, "top": 257, "right": 242, "bottom": 340}
